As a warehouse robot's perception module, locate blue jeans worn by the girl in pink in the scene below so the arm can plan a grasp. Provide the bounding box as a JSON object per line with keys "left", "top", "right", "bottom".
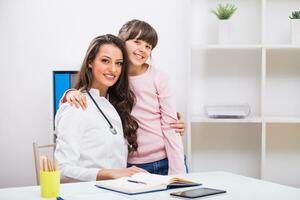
{"left": 127, "top": 158, "right": 169, "bottom": 175}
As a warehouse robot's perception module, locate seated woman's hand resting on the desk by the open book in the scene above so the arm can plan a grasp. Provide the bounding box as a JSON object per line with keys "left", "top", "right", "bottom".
{"left": 97, "top": 166, "right": 148, "bottom": 180}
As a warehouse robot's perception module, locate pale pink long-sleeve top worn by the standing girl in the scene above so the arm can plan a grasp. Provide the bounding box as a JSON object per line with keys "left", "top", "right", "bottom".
{"left": 128, "top": 66, "right": 185, "bottom": 174}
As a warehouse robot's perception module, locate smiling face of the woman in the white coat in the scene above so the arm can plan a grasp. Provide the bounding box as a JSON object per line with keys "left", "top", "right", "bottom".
{"left": 89, "top": 44, "right": 123, "bottom": 95}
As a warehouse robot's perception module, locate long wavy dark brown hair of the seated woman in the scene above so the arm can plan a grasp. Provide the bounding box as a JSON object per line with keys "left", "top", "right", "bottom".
{"left": 75, "top": 34, "right": 138, "bottom": 152}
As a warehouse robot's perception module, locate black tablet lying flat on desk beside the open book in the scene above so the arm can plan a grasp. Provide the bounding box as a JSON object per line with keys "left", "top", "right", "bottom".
{"left": 170, "top": 188, "right": 226, "bottom": 198}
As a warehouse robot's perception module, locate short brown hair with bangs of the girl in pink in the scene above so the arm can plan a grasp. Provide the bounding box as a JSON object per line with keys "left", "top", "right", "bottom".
{"left": 119, "top": 19, "right": 158, "bottom": 49}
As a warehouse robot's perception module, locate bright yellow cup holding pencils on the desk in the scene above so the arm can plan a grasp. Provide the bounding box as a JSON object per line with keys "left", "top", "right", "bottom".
{"left": 40, "top": 171, "right": 60, "bottom": 197}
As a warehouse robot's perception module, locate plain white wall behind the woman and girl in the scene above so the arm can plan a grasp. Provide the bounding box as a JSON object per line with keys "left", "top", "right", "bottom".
{"left": 0, "top": 0, "right": 188, "bottom": 188}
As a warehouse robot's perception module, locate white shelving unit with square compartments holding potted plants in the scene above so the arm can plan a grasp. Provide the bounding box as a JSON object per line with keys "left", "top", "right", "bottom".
{"left": 187, "top": 0, "right": 300, "bottom": 187}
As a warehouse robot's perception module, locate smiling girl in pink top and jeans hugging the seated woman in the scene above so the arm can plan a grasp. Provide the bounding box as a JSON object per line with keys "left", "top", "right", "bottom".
{"left": 62, "top": 20, "right": 186, "bottom": 175}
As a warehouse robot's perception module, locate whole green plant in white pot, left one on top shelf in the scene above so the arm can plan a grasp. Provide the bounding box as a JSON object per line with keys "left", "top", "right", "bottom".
{"left": 211, "top": 4, "right": 237, "bottom": 44}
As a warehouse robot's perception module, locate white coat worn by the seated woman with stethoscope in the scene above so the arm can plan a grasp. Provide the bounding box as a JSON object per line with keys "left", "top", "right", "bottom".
{"left": 55, "top": 89, "right": 128, "bottom": 181}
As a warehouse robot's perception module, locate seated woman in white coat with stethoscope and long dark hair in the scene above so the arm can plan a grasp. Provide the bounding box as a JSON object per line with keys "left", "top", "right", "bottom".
{"left": 55, "top": 35, "right": 145, "bottom": 181}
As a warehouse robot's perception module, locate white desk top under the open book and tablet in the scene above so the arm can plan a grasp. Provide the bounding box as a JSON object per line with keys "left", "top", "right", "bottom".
{"left": 0, "top": 172, "right": 300, "bottom": 200}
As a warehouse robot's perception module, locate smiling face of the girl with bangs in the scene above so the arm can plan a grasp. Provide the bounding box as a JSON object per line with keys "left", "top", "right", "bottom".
{"left": 126, "top": 39, "right": 152, "bottom": 66}
